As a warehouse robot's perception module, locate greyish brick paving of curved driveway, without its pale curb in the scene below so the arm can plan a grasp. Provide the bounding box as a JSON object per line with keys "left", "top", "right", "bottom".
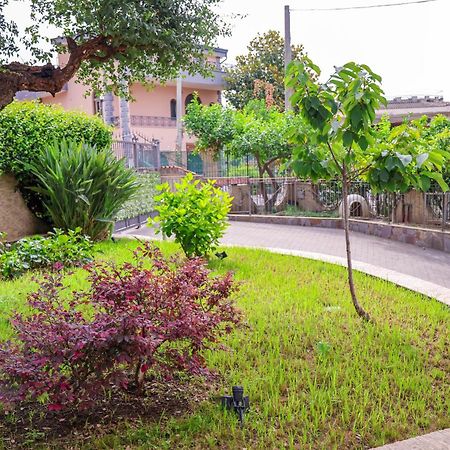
{"left": 119, "top": 222, "right": 450, "bottom": 289}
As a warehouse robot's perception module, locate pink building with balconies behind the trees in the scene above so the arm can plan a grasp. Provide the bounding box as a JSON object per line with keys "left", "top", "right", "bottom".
{"left": 22, "top": 48, "right": 227, "bottom": 170}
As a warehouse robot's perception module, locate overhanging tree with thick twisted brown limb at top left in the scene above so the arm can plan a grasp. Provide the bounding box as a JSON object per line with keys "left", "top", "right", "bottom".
{"left": 0, "top": 0, "right": 228, "bottom": 109}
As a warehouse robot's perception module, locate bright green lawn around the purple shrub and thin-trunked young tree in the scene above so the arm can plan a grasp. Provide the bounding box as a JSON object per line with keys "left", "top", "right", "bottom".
{"left": 0, "top": 237, "right": 450, "bottom": 449}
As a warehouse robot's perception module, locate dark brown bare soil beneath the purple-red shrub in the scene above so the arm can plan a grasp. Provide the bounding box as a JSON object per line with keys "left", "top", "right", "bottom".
{"left": 0, "top": 380, "right": 213, "bottom": 449}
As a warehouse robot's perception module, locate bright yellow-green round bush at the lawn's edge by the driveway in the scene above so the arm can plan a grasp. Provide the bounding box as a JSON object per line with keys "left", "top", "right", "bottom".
{"left": 149, "top": 173, "right": 232, "bottom": 258}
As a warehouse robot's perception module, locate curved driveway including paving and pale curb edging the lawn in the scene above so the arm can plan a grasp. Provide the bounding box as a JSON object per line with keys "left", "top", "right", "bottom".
{"left": 119, "top": 222, "right": 450, "bottom": 305}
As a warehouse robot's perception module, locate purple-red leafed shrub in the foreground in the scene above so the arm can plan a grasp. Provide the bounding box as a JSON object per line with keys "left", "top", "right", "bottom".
{"left": 0, "top": 243, "right": 239, "bottom": 410}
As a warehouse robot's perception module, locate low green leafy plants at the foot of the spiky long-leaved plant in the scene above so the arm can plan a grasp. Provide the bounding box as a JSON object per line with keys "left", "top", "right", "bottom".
{"left": 0, "top": 228, "right": 93, "bottom": 278}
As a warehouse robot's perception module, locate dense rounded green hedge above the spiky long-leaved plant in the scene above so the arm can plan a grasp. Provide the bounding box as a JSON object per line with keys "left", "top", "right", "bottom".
{"left": 0, "top": 101, "right": 112, "bottom": 176}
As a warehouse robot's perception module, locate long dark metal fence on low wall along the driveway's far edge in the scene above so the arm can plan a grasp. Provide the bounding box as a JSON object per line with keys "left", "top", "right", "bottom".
{"left": 217, "top": 177, "right": 450, "bottom": 229}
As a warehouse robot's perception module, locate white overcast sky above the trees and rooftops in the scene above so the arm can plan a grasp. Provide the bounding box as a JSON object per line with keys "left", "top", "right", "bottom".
{"left": 4, "top": 0, "right": 450, "bottom": 101}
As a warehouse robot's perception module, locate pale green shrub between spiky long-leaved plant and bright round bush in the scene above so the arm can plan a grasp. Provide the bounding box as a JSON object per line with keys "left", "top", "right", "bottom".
{"left": 115, "top": 173, "right": 161, "bottom": 220}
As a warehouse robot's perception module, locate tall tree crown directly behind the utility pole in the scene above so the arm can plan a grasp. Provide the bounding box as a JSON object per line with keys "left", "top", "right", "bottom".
{"left": 225, "top": 30, "right": 304, "bottom": 110}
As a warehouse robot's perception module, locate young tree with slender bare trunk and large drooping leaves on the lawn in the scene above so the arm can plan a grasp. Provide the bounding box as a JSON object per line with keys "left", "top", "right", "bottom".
{"left": 287, "top": 58, "right": 448, "bottom": 320}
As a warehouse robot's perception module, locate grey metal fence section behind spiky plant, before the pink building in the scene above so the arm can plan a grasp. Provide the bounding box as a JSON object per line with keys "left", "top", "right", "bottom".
{"left": 112, "top": 141, "right": 161, "bottom": 170}
